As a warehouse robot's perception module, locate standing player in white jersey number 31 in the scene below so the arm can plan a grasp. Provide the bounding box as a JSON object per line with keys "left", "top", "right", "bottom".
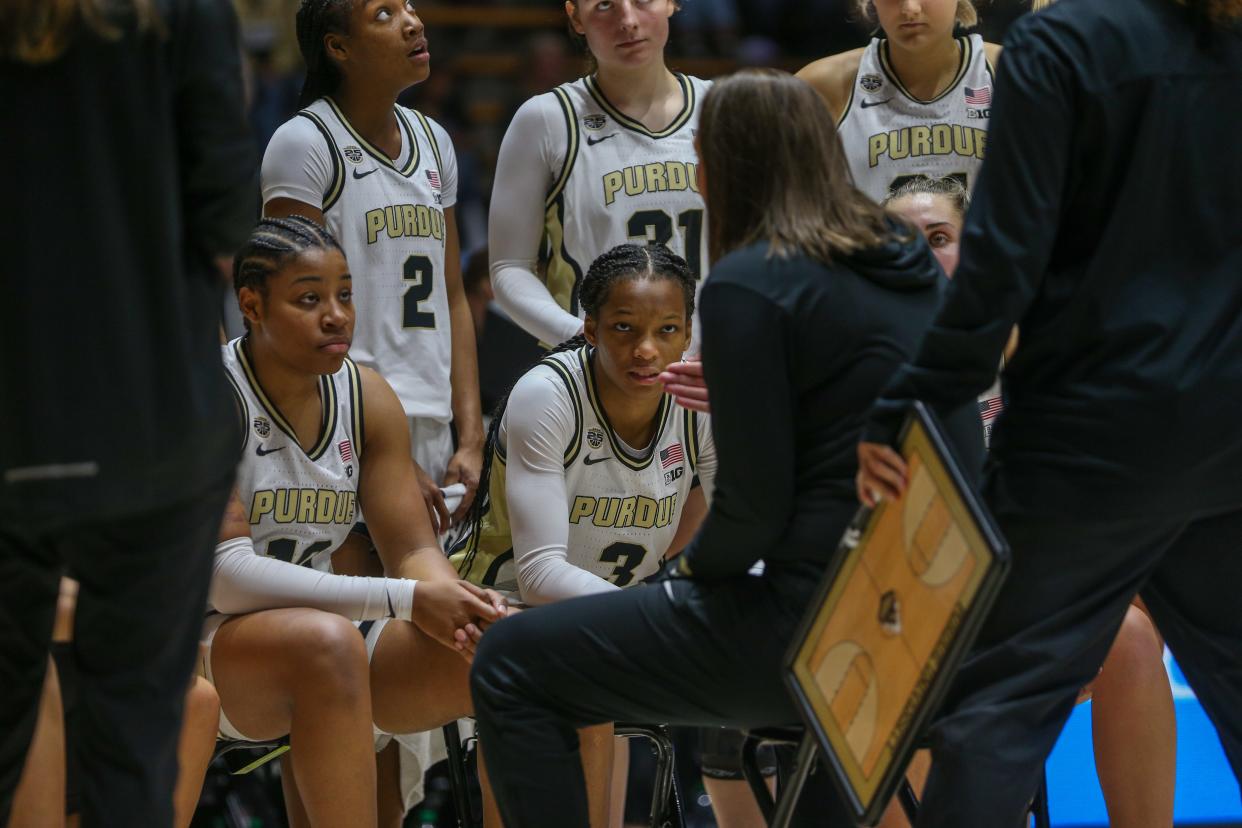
{"left": 488, "top": 0, "right": 708, "bottom": 344}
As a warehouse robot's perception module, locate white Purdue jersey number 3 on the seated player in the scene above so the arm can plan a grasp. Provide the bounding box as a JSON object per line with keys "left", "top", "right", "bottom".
{"left": 452, "top": 346, "right": 715, "bottom": 591}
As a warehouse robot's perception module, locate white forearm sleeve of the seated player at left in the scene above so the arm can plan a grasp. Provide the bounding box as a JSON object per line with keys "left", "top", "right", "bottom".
{"left": 207, "top": 538, "right": 417, "bottom": 621}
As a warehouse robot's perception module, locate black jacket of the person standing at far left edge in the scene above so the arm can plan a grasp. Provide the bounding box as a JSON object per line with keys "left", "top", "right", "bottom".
{"left": 0, "top": 0, "right": 258, "bottom": 526}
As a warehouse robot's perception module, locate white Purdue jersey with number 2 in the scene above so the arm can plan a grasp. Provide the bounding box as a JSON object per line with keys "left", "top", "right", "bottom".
{"left": 298, "top": 98, "right": 452, "bottom": 422}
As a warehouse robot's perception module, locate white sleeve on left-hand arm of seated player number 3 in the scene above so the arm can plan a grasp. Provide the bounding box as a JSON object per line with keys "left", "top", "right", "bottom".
{"left": 502, "top": 369, "right": 617, "bottom": 606}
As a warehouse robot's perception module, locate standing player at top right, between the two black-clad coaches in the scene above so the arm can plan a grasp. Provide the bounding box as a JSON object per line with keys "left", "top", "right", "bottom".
{"left": 797, "top": 0, "right": 1000, "bottom": 201}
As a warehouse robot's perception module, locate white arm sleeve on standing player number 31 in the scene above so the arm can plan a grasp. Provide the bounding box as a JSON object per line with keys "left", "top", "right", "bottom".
{"left": 487, "top": 93, "right": 582, "bottom": 345}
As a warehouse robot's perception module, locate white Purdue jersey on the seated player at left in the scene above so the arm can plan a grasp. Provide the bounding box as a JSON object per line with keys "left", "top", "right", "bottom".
{"left": 224, "top": 339, "right": 363, "bottom": 572}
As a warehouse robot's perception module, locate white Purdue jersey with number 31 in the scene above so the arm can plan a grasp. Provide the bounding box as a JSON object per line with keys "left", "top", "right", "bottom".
{"left": 544, "top": 74, "right": 710, "bottom": 317}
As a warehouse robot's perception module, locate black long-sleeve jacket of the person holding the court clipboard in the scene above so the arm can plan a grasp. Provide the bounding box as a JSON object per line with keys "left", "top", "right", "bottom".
{"left": 867, "top": 0, "right": 1242, "bottom": 518}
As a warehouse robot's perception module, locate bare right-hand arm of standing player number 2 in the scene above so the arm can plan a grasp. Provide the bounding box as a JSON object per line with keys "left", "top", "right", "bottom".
{"left": 443, "top": 207, "right": 483, "bottom": 524}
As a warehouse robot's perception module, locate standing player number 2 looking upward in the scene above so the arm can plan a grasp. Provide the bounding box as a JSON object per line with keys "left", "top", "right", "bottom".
{"left": 262, "top": 0, "right": 483, "bottom": 531}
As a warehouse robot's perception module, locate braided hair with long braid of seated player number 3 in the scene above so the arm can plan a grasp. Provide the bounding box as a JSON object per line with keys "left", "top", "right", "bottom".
{"left": 462, "top": 245, "right": 696, "bottom": 539}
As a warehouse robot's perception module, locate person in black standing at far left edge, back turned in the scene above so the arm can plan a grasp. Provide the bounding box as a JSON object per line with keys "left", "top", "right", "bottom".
{"left": 0, "top": 0, "right": 257, "bottom": 826}
